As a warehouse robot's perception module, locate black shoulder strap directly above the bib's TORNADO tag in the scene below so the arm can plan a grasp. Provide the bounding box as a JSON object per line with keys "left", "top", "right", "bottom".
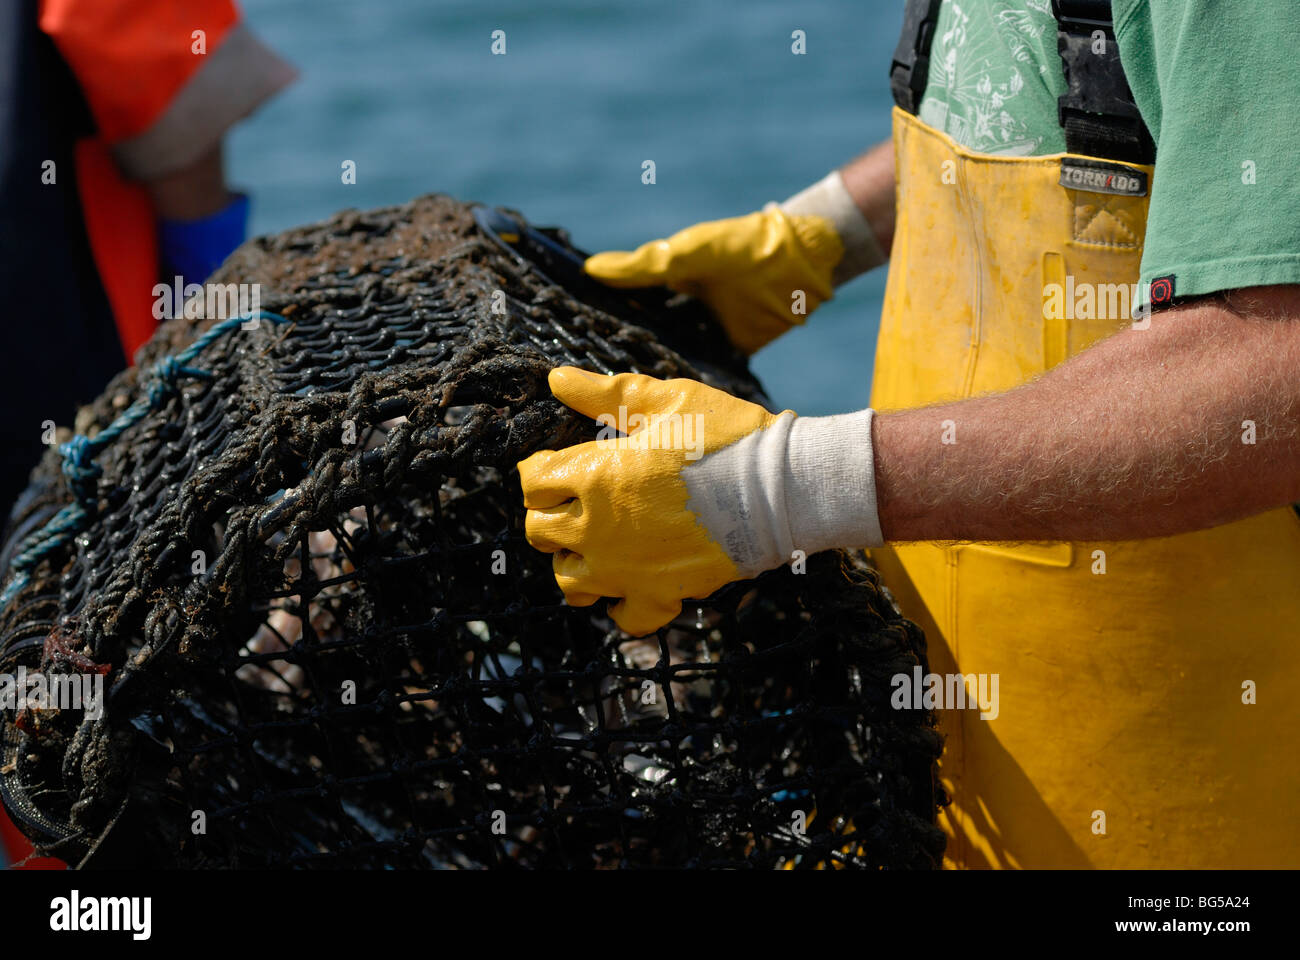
{"left": 1052, "top": 0, "right": 1156, "bottom": 164}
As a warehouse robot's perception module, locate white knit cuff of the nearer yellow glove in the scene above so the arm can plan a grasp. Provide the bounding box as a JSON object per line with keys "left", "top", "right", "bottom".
{"left": 683, "top": 410, "right": 884, "bottom": 576}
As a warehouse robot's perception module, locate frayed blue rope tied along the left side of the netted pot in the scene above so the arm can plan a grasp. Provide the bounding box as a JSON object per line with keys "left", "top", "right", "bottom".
{"left": 0, "top": 310, "right": 289, "bottom": 606}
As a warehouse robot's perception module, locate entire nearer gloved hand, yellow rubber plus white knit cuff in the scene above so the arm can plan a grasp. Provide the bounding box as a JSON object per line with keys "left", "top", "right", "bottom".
{"left": 519, "top": 367, "right": 879, "bottom": 636}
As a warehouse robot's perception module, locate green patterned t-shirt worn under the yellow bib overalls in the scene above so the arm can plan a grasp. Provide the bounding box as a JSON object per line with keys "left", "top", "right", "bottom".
{"left": 919, "top": 0, "right": 1300, "bottom": 310}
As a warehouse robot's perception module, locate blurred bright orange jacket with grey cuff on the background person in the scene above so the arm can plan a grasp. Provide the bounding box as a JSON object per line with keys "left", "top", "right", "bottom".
{"left": 40, "top": 0, "right": 295, "bottom": 359}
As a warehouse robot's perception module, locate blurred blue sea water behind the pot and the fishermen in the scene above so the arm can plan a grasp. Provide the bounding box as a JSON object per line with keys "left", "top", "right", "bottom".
{"left": 228, "top": 0, "right": 902, "bottom": 415}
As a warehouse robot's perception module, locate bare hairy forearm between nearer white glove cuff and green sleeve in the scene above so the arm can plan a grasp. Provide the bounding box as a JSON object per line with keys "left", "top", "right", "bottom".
{"left": 872, "top": 286, "right": 1300, "bottom": 541}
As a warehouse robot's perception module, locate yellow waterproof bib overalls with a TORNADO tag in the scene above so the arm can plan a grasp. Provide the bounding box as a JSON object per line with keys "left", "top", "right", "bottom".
{"left": 872, "top": 108, "right": 1300, "bottom": 868}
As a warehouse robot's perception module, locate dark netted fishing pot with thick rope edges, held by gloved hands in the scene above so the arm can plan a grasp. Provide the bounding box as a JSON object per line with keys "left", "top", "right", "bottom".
{"left": 0, "top": 196, "right": 943, "bottom": 868}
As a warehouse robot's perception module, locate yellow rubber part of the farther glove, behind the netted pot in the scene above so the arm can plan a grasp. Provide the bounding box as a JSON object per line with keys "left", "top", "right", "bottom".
{"left": 586, "top": 204, "right": 844, "bottom": 354}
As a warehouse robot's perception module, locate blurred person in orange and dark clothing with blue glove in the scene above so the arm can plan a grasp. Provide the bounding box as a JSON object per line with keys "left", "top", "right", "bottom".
{"left": 0, "top": 0, "right": 296, "bottom": 860}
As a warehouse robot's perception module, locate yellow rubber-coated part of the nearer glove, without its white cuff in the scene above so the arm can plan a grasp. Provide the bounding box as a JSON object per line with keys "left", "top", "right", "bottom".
{"left": 519, "top": 367, "right": 794, "bottom": 636}
